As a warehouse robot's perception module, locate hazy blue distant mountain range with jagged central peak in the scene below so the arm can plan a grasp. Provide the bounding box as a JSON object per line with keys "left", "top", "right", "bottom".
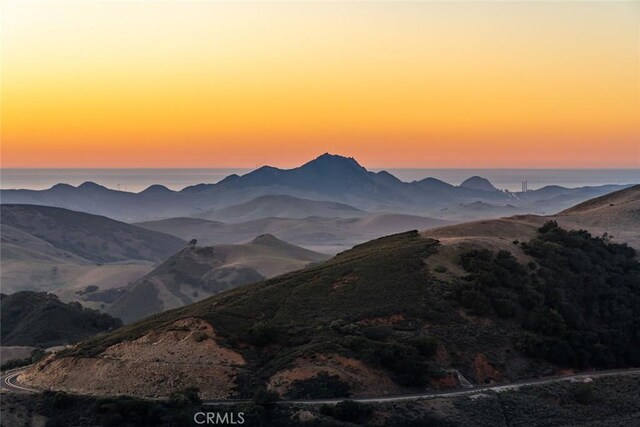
{"left": 0, "top": 154, "right": 625, "bottom": 222}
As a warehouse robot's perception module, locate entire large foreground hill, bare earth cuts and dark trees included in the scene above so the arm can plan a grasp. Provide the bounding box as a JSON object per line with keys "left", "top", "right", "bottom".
{"left": 21, "top": 216, "right": 640, "bottom": 398}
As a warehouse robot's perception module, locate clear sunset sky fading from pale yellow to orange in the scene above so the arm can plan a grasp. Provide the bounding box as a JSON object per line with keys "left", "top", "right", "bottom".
{"left": 0, "top": 1, "right": 640, "bottom": 168}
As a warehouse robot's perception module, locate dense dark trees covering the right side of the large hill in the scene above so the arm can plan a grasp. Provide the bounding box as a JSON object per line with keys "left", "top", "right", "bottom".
{"left": 457, "top": 221, "right": 640, "bottom": 368}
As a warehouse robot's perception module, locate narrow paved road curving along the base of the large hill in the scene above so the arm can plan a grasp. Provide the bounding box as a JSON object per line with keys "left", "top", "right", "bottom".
{"left": 0, "top": 367, "right": 640, "bottom": 405}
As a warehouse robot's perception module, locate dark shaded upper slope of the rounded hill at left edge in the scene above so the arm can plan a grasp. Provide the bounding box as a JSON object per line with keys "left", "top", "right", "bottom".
{"left": 0, "top": 205, "right": 185, "bottom": 263}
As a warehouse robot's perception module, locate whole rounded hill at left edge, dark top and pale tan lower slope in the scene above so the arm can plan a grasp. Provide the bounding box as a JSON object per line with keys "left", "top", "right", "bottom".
{"left": 0, "top": 205, "right": 186, "bottom": 308}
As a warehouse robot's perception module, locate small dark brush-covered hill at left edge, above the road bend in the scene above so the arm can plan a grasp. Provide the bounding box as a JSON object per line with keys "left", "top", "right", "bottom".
{"left": 0, "top": 292, "right": 122, "bottom": 347}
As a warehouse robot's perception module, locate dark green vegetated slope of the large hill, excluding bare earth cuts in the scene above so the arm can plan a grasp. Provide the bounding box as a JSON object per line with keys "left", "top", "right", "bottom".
{"left": 48, "top": 226, "right": 640, "bottom": 397}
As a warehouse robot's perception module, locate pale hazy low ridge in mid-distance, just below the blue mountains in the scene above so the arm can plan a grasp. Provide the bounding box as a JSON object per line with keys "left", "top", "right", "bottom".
{"left": 136, "top": 214, "right": 449, "bottom": 253}
